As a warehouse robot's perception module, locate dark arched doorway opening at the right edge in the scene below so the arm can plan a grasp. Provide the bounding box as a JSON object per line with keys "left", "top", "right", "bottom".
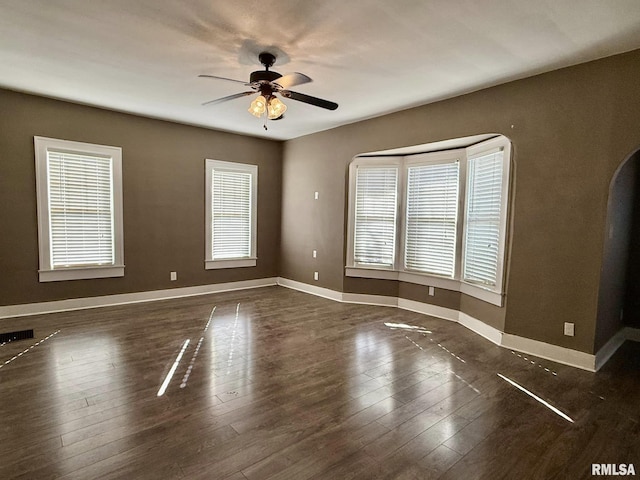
{"left": 594, "top": 149, "right": 640, "bottom": 352}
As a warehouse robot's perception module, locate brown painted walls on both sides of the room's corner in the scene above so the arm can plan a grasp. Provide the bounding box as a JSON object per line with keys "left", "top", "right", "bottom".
{"left": 5, "top": 51, "right": 640, "bottom": 353}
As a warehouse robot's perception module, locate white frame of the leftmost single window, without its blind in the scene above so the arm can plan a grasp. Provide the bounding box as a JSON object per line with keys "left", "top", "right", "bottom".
{"left": 33, "top": 136, "right": 124, "bottom": 282}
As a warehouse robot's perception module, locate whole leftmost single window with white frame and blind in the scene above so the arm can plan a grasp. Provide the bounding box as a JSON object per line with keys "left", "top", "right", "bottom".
{"left": 34, "top": 137, "right": 124, "bottom": 282}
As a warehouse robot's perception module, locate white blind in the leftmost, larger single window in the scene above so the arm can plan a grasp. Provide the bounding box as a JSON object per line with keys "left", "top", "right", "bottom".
{"left": 47, "top": 150, "right": 115, "bottom": 269}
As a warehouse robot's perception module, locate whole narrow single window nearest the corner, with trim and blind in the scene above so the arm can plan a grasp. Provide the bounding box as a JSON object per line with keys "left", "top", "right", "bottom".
{"left": 205, "top": 160, "right": 258, "bottom": 269}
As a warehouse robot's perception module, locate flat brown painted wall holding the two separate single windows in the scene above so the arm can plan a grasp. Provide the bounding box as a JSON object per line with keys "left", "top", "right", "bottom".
{"left": 0, "top": 90, "right": 282, "bottom": 305}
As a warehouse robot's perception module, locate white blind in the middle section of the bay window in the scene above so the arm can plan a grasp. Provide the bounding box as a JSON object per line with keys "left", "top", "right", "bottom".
{"left": 404, "top": 161, "right": 460, "bottom": 277}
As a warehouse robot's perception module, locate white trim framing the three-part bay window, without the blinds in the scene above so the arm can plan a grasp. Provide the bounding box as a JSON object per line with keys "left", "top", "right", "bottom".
{"left": 345, "top": 135, "right": 512, "bottom": 307}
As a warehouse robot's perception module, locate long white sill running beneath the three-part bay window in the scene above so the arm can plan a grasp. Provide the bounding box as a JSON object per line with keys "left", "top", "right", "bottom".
{"left": 345, "top": 267, "right": 504, "bottom": 307}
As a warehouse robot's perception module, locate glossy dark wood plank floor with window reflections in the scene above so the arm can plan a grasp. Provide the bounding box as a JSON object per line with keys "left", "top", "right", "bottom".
{"left": 0, "top": 287, "right": 640, "bottom": 480}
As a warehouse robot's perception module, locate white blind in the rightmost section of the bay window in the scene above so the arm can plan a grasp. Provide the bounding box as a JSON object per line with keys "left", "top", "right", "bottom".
{"left": 463, "top": 150, "right": 504, "bottom": 287}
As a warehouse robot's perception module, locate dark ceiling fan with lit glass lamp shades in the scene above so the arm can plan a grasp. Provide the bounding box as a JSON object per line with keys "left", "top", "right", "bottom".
{"left": 199, "top": 52, "right": 338, "bottom": 130}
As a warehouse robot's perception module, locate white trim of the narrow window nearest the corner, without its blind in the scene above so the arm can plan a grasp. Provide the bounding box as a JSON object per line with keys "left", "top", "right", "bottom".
{"left": 204, "top": 159, "right": 258, "bottom": 270}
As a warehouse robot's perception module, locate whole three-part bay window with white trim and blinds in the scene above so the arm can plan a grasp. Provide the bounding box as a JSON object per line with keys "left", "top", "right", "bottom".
{"left": 346, "top": 136, "right": 510, "bottom": 305}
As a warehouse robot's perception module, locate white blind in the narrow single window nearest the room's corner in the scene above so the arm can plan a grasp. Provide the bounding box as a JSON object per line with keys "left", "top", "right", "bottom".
{"left": 211, "top": 168, "right": 252, "bottom": 260}
